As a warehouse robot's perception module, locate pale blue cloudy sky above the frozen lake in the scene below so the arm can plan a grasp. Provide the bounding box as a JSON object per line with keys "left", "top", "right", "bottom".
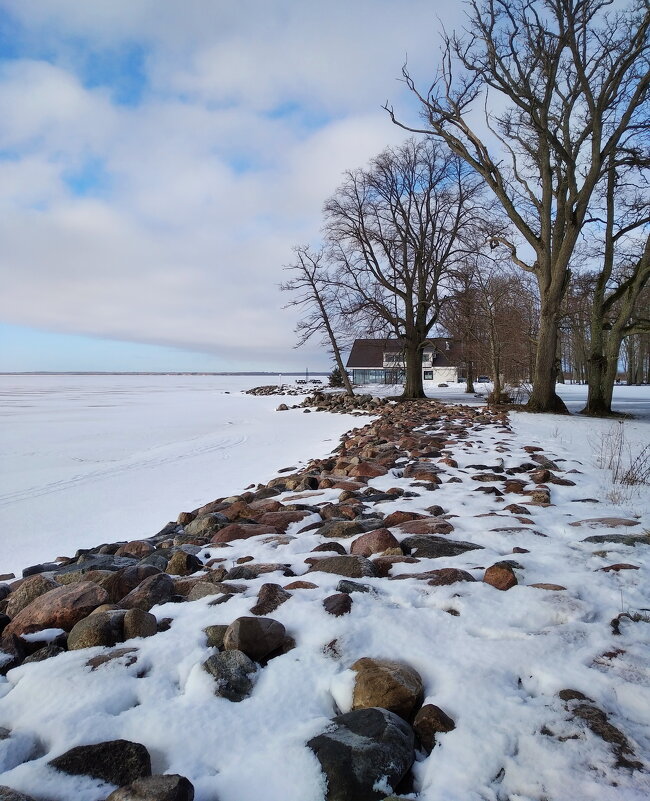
{"left": 0, "top": 0, "right": 462, "bottom": 372}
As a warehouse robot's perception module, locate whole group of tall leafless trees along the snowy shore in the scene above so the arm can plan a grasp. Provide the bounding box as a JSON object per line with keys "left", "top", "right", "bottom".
{"left": 284, "top": 0, "right": 650, "bottom": 414}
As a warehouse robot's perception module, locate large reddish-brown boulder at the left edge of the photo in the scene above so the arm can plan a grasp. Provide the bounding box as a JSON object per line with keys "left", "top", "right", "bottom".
{"left": 3, "top": 581, "right": 108, "bottom": 640}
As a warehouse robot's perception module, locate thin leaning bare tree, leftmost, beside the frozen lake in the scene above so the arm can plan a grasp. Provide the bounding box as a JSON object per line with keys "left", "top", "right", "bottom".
{"left": 280, "top": 247, "right": 354, "bottom": 396}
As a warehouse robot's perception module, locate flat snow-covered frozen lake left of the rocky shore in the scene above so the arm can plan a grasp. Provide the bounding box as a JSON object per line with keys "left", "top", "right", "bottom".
{"left": 0, "top": 375, "right": 358, "bottom": 575}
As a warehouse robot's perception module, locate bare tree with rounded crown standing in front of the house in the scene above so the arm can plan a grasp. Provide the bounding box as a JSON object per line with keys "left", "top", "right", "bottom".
{"left": 324, "top": 139, "right": 485, "bottom": 398}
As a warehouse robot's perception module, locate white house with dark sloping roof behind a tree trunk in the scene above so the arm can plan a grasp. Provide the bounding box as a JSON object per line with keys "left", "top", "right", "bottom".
{"left": 346, "top": 337, "right": 461, "bottom": 386}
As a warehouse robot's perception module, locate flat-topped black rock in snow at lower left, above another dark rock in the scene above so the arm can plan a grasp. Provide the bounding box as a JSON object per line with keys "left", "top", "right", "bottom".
{"left": 49, "top": 740, "right": 151, "bottom": 787}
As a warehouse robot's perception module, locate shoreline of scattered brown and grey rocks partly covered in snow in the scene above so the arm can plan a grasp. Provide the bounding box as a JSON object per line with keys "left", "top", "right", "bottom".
{"left": 0, "top": 387, "right": 649, "bottom": 801}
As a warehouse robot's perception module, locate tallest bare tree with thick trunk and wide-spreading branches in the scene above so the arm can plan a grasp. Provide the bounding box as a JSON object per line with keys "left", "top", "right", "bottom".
{"left": 386, "top": 0, "right": 650, "bottom": 411}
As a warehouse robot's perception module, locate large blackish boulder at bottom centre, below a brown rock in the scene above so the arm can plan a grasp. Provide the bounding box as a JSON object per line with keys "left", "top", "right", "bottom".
{"left": 307, "top": 708, "right": 415, "bottom": 801}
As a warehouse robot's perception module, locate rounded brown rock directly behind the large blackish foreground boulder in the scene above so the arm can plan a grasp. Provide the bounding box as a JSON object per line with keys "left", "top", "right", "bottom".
{"left": 348, "top": 660, "right": 424, "bottom": 720}
